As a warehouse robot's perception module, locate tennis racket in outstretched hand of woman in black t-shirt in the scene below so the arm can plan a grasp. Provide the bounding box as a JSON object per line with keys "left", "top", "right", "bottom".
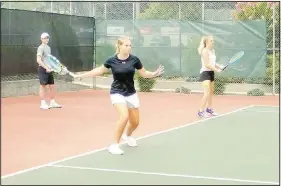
{"left": 44, "top": 54, "right": 75, "bottom": 77}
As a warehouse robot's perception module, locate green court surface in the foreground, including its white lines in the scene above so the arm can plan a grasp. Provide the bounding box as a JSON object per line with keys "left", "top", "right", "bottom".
{"left": 2, "top": 106, "right": 280, "bottom": 185}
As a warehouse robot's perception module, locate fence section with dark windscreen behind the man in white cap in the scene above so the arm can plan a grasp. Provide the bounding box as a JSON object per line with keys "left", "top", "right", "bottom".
{"left": 1, "top": 2, "right": 95, "bottom": 97}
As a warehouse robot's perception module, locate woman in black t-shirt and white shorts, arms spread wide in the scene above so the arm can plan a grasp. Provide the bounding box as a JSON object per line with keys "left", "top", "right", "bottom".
{"left": 72, "top": 37, "right": 164, "bottom": 154}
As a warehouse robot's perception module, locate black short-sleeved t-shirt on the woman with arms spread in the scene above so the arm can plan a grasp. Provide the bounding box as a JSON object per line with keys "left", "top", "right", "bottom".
{"left": 104, "top": 55, "right": 143, "bottom": 96}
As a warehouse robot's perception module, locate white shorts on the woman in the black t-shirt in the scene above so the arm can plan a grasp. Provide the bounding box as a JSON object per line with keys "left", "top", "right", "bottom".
{"left": 110, "top": 93, "right": 140, "bottom": 108}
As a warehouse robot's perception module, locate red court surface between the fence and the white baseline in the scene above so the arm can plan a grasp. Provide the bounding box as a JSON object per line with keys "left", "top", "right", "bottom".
{"left": 1, "top": 90, "right": 279, "bottom": 176}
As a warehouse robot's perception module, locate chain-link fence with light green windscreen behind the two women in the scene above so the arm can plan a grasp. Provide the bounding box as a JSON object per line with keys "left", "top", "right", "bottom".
{"left": 2, "top": 1, "right": 280, "bottom": 95}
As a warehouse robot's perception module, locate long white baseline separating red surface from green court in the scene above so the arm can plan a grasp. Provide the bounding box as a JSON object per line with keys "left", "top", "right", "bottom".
{"left": 1, "top": 105, "right": 254, "bottom": 179}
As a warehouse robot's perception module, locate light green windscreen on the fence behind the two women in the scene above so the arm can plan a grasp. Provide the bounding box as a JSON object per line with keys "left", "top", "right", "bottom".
{"left": 96, "top": 20, "right": 266, "bottom": 77}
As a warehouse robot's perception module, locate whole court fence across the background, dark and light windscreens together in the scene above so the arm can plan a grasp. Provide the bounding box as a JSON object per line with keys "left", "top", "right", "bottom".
{"left": 1, "top": 1, "right": 280, "bottom": 96}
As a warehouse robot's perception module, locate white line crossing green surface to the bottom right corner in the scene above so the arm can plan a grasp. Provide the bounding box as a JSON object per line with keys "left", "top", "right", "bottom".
{"left": 49, "top": 165, "right": 279, "bottom": 185}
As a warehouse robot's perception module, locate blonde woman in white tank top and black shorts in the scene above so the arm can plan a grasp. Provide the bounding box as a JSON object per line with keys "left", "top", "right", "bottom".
{"left": 198, "top": 36, "right": 222, "bottom": 117}
